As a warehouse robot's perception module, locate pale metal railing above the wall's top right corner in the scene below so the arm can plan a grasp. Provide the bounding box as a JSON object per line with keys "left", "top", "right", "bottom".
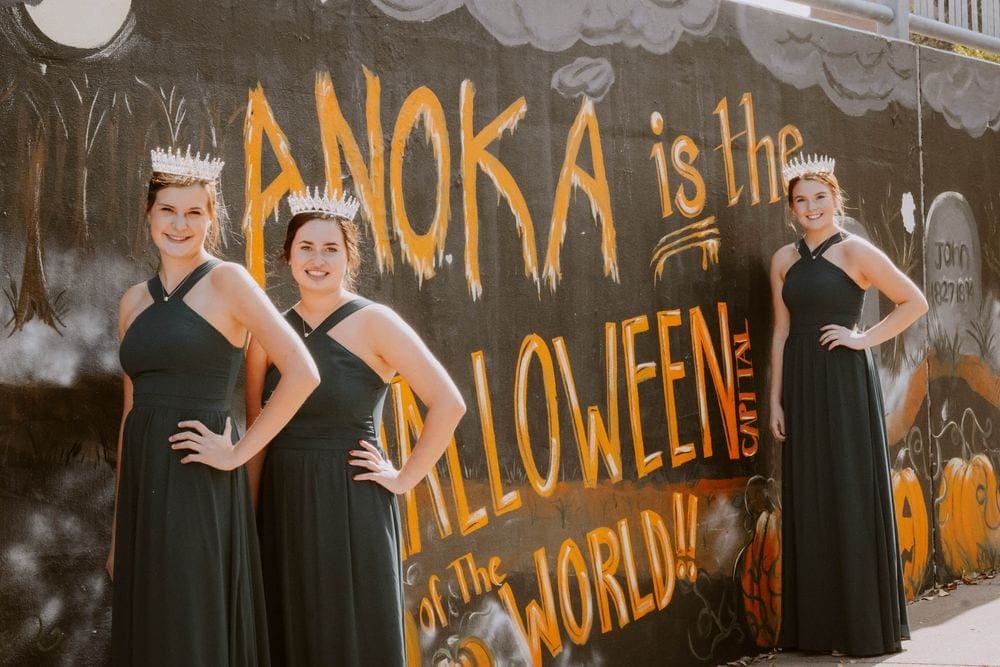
{"left": 794, "top": 0, "right": 1000, "bottom": 53}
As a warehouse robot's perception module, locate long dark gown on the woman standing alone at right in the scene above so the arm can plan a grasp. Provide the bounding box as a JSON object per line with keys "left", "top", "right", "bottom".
{"left": 779, "top": 232, "right": 909, "bottom": 656}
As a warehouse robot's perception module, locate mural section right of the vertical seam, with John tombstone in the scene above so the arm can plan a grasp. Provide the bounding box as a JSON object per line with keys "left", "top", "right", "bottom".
{"left": 919, "top": 45, "right": 1000, "bottom": 579}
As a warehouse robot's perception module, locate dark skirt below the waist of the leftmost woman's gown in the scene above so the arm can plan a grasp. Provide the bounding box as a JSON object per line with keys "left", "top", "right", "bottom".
{"left": 111, "top": 398, "right": 270, "bottom": 667}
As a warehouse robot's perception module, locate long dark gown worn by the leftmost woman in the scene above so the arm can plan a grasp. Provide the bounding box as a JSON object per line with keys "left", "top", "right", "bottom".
{"left": 111, "top": 260, "right": 269, "bottom": 667}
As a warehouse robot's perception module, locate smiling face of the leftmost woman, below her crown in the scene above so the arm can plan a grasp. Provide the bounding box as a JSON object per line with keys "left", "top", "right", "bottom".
{"left": 146, "top": 183, "right": 214, "bottom": 259}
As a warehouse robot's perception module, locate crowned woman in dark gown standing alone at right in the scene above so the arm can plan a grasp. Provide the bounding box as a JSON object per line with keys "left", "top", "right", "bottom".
{"left": 770, "top": 156, "right": 927, "bottom": 656}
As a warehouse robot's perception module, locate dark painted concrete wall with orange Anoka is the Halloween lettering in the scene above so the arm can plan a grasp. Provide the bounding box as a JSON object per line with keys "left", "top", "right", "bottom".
{"left": 0, "top": 0, "right": 1000, "bottom": 665}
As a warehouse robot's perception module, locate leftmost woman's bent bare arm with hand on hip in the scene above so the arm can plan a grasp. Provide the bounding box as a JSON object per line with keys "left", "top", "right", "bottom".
{"left": 170, "top": 264, "right": 319, "bottom": 470}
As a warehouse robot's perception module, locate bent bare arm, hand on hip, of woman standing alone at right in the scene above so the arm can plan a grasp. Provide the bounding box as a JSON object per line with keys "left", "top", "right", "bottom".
{"left": 820, "top": 239, "right": 927, "bottom": 350}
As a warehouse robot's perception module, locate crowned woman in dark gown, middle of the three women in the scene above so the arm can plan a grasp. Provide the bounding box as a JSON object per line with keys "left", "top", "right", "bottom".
{"left": 246, "top": 193, "right": 465, "bottom": 666}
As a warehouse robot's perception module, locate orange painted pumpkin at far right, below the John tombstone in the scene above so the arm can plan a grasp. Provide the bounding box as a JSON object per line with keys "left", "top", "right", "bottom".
{"left": 938, "top": 454, "right": 1000, "bottom": 575}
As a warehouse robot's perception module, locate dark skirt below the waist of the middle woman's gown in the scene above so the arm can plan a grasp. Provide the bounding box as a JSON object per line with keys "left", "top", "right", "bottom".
{"left": 258, "top": 436, "right": 405, "bottom": 666}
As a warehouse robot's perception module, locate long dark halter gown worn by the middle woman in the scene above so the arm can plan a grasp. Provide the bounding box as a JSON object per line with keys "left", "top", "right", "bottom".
{"left": 258, "top": 298, "right": 405, "bottom": 667}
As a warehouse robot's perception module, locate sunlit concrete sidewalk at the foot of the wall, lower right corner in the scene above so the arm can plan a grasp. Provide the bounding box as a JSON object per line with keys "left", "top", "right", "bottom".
{"left": 751, "top": 577, "right": 1000, "bottom": 667}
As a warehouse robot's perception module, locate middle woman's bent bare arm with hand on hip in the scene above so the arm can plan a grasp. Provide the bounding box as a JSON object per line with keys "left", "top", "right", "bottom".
{"left": 350, "top": 306, "right": 465, "bottom": 493}
